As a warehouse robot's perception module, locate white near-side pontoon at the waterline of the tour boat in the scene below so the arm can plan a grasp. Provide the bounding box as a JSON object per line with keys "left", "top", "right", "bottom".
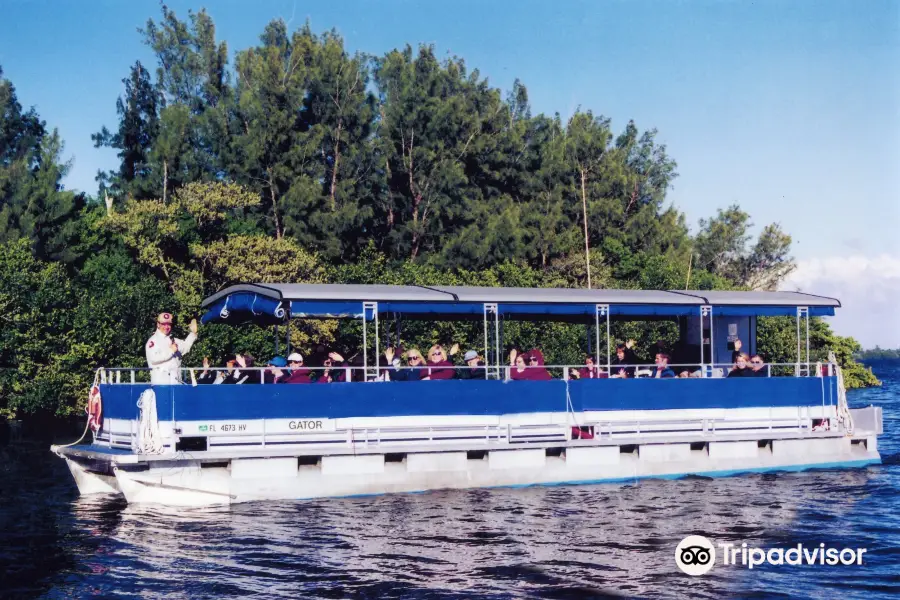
{"left": 115, "top": 436, "right": 880, "bottom": 506}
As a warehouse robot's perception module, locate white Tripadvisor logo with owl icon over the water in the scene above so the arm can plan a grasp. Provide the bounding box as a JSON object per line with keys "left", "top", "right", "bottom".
{"left": 675, "top": 535, "right": 866, "bottom": 575}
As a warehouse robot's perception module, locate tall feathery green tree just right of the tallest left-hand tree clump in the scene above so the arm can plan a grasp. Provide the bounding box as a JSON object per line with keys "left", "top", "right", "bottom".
{"left": 232, "top": 20, "right": 375, "bottom": 253}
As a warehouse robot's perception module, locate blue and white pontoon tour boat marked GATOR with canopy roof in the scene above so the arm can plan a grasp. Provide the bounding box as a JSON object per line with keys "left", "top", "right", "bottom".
{"left": 52, "top": 284, "right": 882, "bottom": 506}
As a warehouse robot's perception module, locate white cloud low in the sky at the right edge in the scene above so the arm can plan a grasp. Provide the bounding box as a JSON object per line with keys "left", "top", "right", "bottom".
{"left": 781, "top": 254, "right": 900, "bottom": 348}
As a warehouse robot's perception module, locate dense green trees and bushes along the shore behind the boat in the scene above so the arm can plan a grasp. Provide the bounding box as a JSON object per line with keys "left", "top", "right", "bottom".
{"left": 0, "top": 6, "right": 871, "bottom": 415}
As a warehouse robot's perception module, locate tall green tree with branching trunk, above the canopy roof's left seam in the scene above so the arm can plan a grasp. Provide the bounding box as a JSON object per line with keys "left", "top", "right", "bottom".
{"left": 374, "top": 46, "right": 502, "bottom": 259}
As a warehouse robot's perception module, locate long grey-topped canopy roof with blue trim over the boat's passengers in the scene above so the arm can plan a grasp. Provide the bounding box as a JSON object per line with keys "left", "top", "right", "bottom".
{"left": 202, "top": 284, "right": 841, "bottom": 324}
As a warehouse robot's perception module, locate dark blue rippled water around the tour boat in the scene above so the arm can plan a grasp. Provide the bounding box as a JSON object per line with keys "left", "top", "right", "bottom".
{"left": 0, "top": 362, "right": 900, "bottom": 598}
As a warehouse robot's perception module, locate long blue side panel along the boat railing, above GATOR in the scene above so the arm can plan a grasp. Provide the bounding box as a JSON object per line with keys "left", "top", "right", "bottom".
{"left": 101, "top": 377, "right": 836, "bottom": 421}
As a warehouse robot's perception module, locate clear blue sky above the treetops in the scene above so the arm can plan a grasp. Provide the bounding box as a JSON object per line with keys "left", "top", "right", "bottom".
{"left": 0, "top": 0, "right": 900, "bottom": 346}
